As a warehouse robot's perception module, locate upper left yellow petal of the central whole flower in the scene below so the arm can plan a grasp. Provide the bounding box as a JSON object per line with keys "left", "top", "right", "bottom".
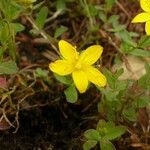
{"left": 58, "top": 40, "right": 78, "bottom": 62}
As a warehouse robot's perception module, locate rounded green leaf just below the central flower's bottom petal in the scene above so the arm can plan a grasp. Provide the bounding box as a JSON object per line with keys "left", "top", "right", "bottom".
{"left": 64, "top": 85, "right": 78, "bottom": 103}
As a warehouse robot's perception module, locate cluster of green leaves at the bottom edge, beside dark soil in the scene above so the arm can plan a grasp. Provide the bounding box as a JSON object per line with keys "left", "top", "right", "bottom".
{"left": 83, "top": 120, "right": 126, "bottom": 150}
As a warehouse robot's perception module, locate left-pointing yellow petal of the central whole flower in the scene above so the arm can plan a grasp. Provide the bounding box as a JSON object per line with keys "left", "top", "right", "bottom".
{"left": 49, "top": 60, "right": 73, "bottom": 76}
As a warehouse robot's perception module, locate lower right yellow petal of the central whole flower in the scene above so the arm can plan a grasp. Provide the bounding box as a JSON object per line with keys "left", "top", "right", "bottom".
{"left": 85, "top": 66, "right": 107, "bottom": 87}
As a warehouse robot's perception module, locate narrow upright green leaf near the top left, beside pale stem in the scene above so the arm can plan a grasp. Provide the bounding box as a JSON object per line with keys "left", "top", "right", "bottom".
{"left": 35, "top": 6, "right": 48, "bottom": 29}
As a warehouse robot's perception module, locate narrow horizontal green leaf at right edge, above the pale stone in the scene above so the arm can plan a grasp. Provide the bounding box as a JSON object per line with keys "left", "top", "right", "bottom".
{"left": 129, "top": 48, "right": 150, "bottom": 57}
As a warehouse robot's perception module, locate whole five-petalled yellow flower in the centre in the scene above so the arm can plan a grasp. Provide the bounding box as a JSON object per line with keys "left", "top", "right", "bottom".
{"left": 49, "top": 40, "right": 106, "bottom": 93}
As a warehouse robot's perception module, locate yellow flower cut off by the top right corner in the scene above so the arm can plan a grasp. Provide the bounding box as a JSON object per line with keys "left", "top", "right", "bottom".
{"left": 132, "top": 0, "right": 150, "bottom": 35}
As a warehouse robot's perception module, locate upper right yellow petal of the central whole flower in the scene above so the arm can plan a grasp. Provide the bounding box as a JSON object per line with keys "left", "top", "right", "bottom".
{"left": 79, "top": 45, "right": 103, "bottom": 65}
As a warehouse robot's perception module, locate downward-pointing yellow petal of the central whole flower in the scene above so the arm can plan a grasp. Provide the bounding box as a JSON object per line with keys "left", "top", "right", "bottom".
{"left": 72, "top": 70, "right": 88, "bottom": 93}
